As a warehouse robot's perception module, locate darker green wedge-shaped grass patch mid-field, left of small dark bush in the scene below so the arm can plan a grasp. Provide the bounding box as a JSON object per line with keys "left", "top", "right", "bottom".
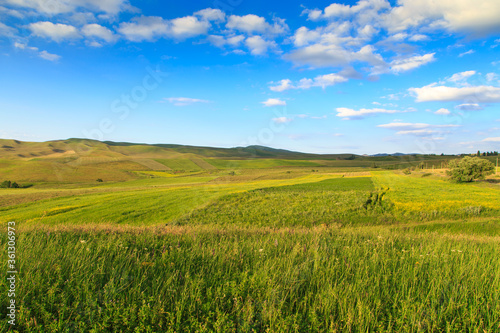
{"left": 174, "top": 177, "right": 391, "bottom": 227}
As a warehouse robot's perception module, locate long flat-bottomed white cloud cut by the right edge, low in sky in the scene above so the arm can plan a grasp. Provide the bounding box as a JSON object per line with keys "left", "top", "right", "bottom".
{"left": 408, "top": 83, "right": 500, "bottom": 103}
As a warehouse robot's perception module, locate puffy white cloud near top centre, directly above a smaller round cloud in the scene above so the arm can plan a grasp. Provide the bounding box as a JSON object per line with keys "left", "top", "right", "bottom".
{"left": 226, "top": 14, "right": 288, "bottom": 34}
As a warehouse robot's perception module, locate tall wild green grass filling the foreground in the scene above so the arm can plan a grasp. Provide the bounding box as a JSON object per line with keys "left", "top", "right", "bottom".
{"left": 0, "top": 227, "right": 500, "bottom": 332}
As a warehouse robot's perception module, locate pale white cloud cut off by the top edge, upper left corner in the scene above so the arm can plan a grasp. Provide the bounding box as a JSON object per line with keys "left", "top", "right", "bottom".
{"left": 5, "top": 0, "right": 134, "bottom": 15}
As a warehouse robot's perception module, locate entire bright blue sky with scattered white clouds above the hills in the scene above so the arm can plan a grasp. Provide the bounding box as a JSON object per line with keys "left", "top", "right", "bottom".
{"left": 0, "top": 0, "right": 500, "bottom": 154}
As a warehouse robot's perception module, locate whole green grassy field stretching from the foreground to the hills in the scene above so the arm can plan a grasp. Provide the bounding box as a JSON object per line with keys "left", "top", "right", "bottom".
{"left": 0, "top": 141, "right": 500, "bottom": 332}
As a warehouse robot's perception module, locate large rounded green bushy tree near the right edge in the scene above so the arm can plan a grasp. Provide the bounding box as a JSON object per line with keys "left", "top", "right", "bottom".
{"left": 447, "top": 156, "right": 495, "bottom": 182}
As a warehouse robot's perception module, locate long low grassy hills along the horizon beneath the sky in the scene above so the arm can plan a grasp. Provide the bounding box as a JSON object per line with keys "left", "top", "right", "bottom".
{"left": 0, "top": 138, "right": 460, "bottom": 182}
